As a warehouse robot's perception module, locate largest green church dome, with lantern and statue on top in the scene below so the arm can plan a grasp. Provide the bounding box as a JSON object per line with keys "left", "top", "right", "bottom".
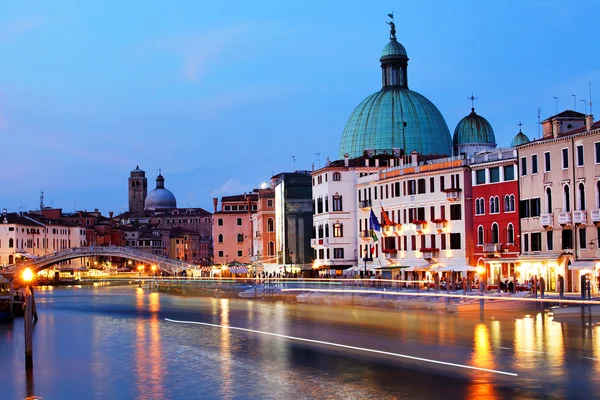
{"left": 338, "top": 22, "right": 452, "bottom": 159}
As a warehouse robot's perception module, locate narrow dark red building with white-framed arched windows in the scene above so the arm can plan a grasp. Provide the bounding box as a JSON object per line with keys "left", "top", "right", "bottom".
{"left": 471, "top": 149, "right": 520, "bottom": 283}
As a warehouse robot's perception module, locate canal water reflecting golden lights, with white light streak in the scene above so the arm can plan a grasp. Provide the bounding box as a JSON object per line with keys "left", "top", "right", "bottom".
{"left": 0, "top": 286, "right": 600, "bottom": 399}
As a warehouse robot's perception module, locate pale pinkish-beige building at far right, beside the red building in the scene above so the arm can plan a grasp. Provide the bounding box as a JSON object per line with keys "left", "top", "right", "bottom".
{"left": 517, "top": 111, "right": 600, "bottom": 292}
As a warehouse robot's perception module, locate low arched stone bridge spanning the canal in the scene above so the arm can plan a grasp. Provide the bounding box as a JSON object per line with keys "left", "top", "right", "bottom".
{"left": 0, "top": 246, "right": 200, "bottom": 278}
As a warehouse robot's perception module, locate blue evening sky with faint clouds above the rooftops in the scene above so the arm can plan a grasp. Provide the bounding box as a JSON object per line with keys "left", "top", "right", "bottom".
{"left": 0, "top": 0, "right": 600, "bottom": 214}
